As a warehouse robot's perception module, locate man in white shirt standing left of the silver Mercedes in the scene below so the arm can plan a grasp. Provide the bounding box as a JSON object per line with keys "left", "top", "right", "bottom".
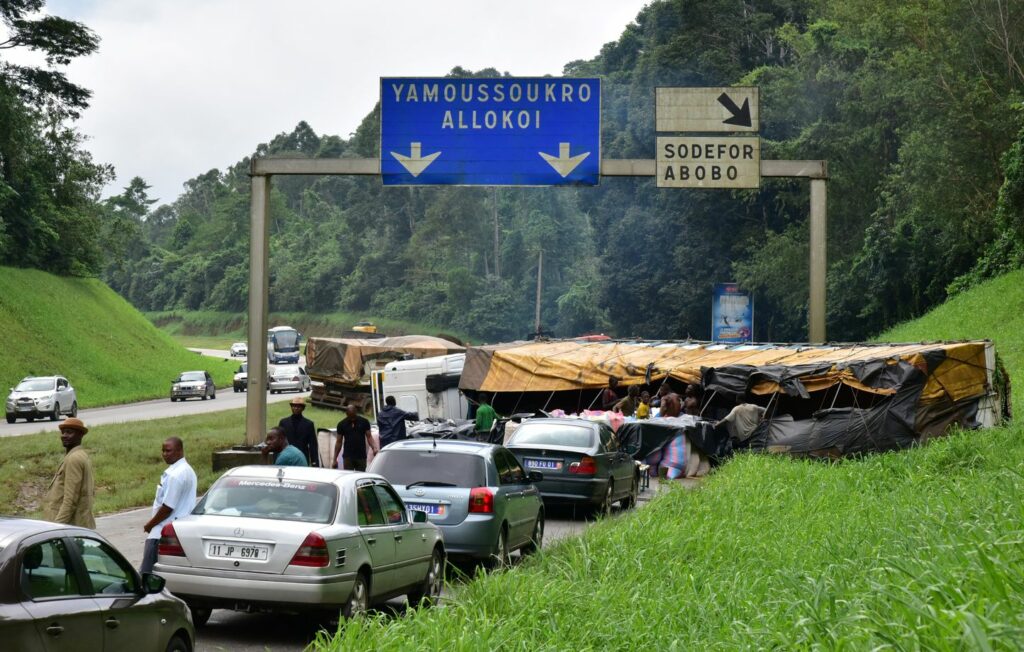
{"left": 139, "top": 437, "right": 197, "bottom": 573}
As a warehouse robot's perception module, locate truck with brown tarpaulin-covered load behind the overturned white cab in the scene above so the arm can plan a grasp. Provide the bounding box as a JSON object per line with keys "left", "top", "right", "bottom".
{"left": 306, "top": 335, "right": 466, "bottom": 411}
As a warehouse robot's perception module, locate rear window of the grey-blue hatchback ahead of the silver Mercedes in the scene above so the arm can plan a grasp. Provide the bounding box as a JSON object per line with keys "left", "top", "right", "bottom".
{"left": 370, "top": 448, "right": 486, "bottom": 487}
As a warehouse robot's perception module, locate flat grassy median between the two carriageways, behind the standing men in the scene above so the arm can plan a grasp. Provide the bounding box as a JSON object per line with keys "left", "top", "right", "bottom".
{"left": 0, "top": 403, "right": 342, "bottom": 516}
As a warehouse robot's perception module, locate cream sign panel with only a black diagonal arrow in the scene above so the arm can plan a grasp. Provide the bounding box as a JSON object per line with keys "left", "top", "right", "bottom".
{"left": 654, "top": 86, "right": 760, "bottom": 133}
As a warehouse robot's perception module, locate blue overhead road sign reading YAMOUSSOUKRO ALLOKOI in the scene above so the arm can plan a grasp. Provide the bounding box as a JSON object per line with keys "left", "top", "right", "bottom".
{"left": 381, "top": 77, "right": 601, "bottom": 185}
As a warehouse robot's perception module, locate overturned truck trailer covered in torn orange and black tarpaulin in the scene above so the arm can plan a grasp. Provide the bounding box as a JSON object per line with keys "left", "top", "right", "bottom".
{"left": 460, "top": 340, "right": 1010, "bottom": 458}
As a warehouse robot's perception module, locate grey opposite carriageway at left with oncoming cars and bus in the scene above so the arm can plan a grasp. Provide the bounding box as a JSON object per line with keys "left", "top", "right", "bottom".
{"left": 0, "top": 349, "right": 309, "bottom": 437}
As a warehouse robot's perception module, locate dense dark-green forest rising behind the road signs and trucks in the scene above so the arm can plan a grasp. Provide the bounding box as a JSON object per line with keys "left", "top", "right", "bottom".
{"left": 6, "top": 0, "right": 1024, "bottom": 341}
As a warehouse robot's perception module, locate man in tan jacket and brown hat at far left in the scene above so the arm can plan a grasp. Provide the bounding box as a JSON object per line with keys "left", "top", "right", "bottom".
{"left": 43, "top": 417, "right": 96, "bottom": 529}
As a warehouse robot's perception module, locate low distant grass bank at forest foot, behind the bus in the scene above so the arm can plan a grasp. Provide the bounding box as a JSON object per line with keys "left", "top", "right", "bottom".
{"left": 145, "top": 310, "right": 467, "bottom": 349}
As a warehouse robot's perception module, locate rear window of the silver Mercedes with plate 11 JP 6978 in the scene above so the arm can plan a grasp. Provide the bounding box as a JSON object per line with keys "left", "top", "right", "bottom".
{"left": 193, "top": 477, "right": 338, "bottom": 523}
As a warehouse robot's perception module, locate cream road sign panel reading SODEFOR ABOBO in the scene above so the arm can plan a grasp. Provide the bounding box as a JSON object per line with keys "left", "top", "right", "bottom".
{"left": 655, "top": 136, "right": 761, "bottom": 188}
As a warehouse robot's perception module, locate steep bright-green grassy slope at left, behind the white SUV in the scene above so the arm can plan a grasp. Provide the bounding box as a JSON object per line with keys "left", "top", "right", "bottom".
{"left": 0, "top": 267, "right": 238, "bottom": 408}
